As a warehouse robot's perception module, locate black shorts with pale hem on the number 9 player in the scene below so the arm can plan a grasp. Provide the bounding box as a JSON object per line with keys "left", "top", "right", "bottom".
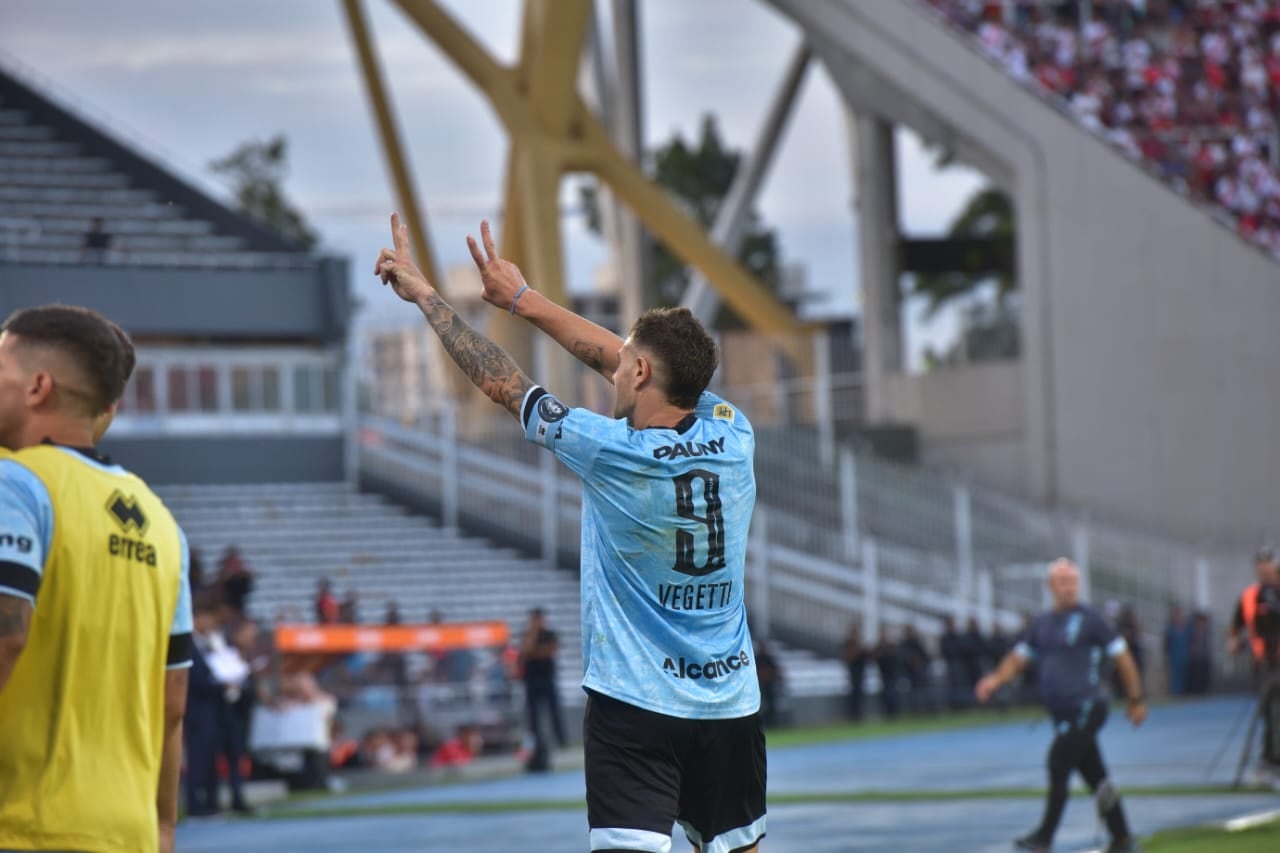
{"left": 582, "top": 692, "right": 765, "bottom": 853}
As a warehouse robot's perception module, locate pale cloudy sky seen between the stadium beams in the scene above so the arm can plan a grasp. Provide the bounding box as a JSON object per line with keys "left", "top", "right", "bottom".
{"left": 0, "top": 0, "right": 980, "bottom": 343}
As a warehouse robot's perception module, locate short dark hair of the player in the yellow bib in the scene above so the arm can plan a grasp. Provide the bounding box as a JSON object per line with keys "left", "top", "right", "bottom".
{"left": 0, "top": 305, "right": 136, "bottom": 416}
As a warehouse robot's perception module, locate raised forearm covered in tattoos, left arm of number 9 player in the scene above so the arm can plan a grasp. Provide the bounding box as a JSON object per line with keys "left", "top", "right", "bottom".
{"left": 374, "top": 214, "right": 534, "bottom": 420}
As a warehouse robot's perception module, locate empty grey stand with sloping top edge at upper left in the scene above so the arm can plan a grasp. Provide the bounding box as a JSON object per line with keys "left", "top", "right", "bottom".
{"left": 0, "top": 56, "right": 352, "bottom": 483}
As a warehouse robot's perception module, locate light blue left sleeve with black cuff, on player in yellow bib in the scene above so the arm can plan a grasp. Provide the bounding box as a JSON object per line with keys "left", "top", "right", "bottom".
{"left": 0, "top": 460, "right": 54, "bottom": 605}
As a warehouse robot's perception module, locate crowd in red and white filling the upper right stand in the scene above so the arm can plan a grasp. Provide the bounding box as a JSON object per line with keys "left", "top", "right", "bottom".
{"left": 928, "top": 0, "right": 1280, "bottom": 259}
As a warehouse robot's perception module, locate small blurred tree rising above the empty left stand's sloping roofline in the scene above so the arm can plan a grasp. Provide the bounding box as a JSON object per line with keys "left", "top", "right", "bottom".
{"left": 209, "top": 134, "right": 320, "bottom": 248}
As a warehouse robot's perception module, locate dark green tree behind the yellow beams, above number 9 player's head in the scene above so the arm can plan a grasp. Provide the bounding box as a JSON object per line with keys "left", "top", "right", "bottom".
{"left": 581, "top": 114, "right": 778, "bottom": 329}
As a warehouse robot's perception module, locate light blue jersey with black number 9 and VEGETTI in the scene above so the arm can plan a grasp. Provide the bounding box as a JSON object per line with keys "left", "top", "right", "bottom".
{"left": 521, "top": 388, "right": 760, "bottom": 720}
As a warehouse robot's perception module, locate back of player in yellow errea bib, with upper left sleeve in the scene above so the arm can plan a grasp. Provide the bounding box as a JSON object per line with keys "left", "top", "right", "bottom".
{"left": 0, "top": 444, "right": 186, "bottom": 850}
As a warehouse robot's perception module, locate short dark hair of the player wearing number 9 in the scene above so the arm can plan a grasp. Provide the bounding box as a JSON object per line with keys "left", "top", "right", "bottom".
{"left": 631, "top": 307, "right": 719, "bottom": 409}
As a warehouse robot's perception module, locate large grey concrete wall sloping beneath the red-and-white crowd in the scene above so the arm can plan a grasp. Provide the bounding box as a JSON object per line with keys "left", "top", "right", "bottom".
{"left": 772, "top": 0, "right": 1280, "bottom": 546}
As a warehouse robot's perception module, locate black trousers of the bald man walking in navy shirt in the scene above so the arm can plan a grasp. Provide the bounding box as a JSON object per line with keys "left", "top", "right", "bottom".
{"left": 1036, "top": 701, "right": 1129, "bottom": 844}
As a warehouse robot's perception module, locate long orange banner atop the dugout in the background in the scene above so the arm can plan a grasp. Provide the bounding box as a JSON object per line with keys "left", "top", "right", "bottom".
{"left": 275, "top": 622, "right": 511, "bottom": 654}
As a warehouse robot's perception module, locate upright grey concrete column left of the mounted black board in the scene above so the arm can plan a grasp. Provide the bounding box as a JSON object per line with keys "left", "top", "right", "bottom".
{"left": 846, "top": 110, "right": 902, "bottom": 424}
